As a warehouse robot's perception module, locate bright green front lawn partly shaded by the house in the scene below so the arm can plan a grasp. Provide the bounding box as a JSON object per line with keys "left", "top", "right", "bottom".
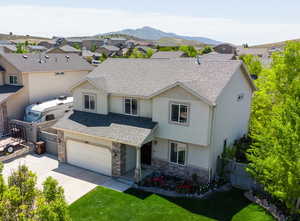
{"left": 70, "top": 187, "right": 273, "bottom": 221}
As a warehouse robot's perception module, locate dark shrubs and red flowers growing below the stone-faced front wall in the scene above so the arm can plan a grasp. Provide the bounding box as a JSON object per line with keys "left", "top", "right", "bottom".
{"left": 140, "top": 173, "right": 225, "bottom": 195}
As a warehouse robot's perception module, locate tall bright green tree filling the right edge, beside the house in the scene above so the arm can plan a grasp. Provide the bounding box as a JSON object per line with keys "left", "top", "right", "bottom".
{"left": 248, "top": 43, "right": 300, "bottom": 213}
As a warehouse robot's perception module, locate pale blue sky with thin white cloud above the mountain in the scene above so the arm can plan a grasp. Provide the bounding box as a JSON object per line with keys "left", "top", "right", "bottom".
{"left": 0, "top": 0, "right": 300, "bottom": 44}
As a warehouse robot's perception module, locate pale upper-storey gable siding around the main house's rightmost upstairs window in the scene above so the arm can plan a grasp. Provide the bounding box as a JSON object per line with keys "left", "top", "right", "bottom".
{"left": 152, "top": 88, "right": 210, "bottom": 146}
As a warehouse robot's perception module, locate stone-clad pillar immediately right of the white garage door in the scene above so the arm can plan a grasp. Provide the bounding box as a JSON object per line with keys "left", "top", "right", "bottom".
{"left": 112, "top": 142, "right": 126, "bottom": 177}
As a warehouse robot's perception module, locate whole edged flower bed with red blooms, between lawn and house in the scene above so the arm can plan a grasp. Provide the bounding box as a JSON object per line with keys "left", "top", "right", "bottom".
{"left": 138, "top": 173, "right": 229, "bottom": 197}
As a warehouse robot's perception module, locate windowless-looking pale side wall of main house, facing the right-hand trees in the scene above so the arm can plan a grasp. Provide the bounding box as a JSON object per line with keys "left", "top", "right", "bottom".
{"left": 211, "top": 69, "right": 252, "bottom": 173}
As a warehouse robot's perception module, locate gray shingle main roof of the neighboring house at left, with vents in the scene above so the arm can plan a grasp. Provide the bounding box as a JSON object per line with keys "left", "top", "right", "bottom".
{"left": 1, "top": 53, "right": 94, "bottom": 72}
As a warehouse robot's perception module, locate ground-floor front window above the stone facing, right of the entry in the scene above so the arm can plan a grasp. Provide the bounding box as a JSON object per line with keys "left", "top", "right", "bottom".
{"left": 170, "top": 141, "right": 187, "bottom": 165}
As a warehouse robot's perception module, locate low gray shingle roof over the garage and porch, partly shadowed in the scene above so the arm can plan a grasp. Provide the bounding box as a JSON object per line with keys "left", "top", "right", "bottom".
{"left": 53, "top": 111, "right": 157, "bottom": 146}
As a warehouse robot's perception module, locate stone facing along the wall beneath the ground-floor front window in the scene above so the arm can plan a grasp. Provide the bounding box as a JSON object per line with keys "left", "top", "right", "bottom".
{"left": 151, "top": 158, "right": 209, "bottom": 182}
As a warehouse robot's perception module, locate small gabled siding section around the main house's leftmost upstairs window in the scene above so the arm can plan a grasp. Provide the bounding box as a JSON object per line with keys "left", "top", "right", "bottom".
{"left": 72, "top": 82, "right": 108, "bottom": 114}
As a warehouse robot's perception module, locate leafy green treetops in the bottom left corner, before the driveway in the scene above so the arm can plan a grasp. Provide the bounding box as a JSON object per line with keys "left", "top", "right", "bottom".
{"left": 0, "top": 165, "right": 70, "bottom": 221}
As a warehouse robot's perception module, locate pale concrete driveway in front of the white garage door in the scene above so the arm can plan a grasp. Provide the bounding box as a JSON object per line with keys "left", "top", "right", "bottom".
{"left": 3, "top": 154, "right": 130, "bottom": 204}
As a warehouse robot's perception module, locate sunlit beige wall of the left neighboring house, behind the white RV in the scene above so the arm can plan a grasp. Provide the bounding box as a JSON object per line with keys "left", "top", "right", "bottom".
{"left": 28, "top": 71, "right": 88, "bottom": 103}
